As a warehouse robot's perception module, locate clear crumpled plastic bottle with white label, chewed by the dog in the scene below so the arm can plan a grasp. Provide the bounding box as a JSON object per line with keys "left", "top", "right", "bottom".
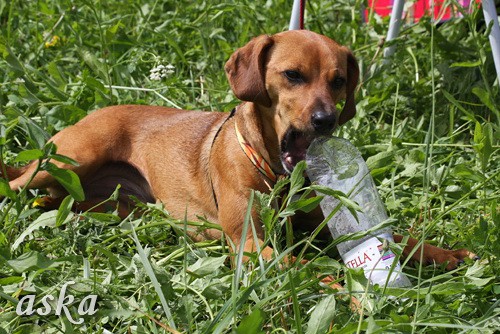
{"left": 306, "top": 137, "right": 411, "bottom": 287}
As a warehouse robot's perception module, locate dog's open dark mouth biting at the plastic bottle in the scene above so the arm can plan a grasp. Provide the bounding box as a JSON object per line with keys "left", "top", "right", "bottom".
{"left": 280, "top": 128, "right": 315, "bottom": 173}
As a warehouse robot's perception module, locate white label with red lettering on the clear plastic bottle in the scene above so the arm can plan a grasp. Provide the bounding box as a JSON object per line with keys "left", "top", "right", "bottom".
{"left": 342, "top": 236, "right": 401, "bottom": 285}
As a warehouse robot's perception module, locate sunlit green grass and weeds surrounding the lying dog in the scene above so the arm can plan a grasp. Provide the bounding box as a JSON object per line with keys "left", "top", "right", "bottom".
{"left": 0, "top": 0, "right": 500, "bottom": 333}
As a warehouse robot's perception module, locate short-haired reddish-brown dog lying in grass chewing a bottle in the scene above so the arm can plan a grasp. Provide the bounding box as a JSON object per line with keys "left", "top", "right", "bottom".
{"left": 2, "top": 30, "right": 471, "bottom": 269}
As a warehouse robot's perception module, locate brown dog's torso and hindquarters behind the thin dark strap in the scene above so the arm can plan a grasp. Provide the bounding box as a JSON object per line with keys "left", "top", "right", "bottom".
{"left": 2, "top": 105, "right": 228, "bottom": 217}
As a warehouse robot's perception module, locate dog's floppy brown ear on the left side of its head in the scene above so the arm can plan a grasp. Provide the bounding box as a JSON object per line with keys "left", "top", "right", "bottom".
{"left": 225, "top": 35, "right": 274, "bottom": 107}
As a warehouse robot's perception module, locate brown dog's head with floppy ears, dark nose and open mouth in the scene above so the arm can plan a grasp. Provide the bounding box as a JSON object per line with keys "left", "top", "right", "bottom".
{"left": 226, "top": 30, "right": 359, "bottom": 172}
